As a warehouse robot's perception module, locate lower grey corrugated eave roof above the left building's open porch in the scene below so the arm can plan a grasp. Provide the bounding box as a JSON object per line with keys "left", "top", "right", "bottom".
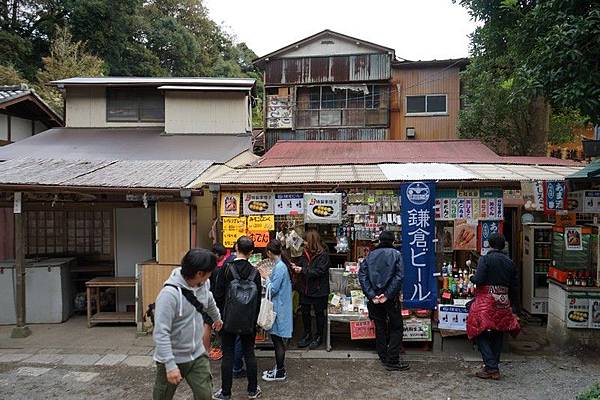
{"left": 0, "top": 159, "right": 212, "bottom": 189}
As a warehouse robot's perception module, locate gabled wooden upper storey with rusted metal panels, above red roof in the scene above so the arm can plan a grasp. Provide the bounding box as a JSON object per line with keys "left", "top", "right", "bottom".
{"left": 255, "top": 30, "right": 467, "bottom": 149}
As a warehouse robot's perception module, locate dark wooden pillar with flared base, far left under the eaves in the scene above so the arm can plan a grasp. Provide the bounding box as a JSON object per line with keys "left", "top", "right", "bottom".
{"left": 11, "top": 192, "right": 31, "bottom": 338}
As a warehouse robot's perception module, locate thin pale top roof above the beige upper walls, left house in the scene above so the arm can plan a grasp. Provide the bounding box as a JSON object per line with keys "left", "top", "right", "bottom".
{"left": 50, "top": 76, "right": 256, "bottom": 87}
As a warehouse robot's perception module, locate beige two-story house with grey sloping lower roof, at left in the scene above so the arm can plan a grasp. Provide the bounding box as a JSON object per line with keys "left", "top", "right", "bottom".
{"left": 0, "top": 77, "right": 255, "bottom": 330}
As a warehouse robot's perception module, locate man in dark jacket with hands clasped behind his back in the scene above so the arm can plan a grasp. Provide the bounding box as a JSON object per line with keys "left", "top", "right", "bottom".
{"left": 358, "top": 231, "right": 409, "bottom": 371}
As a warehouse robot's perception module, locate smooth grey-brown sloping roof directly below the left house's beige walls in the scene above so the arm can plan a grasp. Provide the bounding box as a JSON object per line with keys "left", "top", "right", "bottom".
{"left": 0, "top": 127, "right": 252, "bottom": 163}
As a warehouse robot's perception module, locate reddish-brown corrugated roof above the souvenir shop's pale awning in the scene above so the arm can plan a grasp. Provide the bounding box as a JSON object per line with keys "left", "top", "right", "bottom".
{"left": 259, "top": 140, "right": 580, "bottom": 167}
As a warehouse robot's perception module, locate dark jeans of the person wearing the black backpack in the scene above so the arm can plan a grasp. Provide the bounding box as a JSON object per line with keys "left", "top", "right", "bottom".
{"left": 221, "top": 332, "right": 258, "bottom": 396}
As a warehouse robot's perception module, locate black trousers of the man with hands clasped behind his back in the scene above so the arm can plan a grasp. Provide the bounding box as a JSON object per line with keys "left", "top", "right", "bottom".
{"left": 367, "top": 298, "right": 404, "bottom": 364}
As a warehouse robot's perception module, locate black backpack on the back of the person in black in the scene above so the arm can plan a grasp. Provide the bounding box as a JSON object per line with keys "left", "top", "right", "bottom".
{"left": 223, "top": 264, "right": 260, "bottom": 335}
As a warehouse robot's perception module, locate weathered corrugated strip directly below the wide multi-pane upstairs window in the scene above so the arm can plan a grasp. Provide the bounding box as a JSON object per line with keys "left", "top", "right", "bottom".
{"left": 265, "top": 128, "right": 389, "bottom": 149}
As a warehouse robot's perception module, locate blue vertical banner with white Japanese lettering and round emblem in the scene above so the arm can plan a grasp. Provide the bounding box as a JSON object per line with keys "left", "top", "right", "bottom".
{"left": 400, "top": 182, "right": 437, "bottom": 309}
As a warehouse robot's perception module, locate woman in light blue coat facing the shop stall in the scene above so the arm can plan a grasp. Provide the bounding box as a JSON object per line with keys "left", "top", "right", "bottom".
{"left": 263, "top": 240, "right": 294, "bottom": 382}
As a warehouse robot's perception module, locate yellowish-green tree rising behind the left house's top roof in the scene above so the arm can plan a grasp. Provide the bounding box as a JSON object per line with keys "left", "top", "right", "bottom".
{"left": 35, "top": 28, "right": 105, "bottom": 112}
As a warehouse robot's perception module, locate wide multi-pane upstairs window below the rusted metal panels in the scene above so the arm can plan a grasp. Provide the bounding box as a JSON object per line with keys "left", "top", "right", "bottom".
{"left": 296, "top": 84, "right": 389, "bottom": 128}
